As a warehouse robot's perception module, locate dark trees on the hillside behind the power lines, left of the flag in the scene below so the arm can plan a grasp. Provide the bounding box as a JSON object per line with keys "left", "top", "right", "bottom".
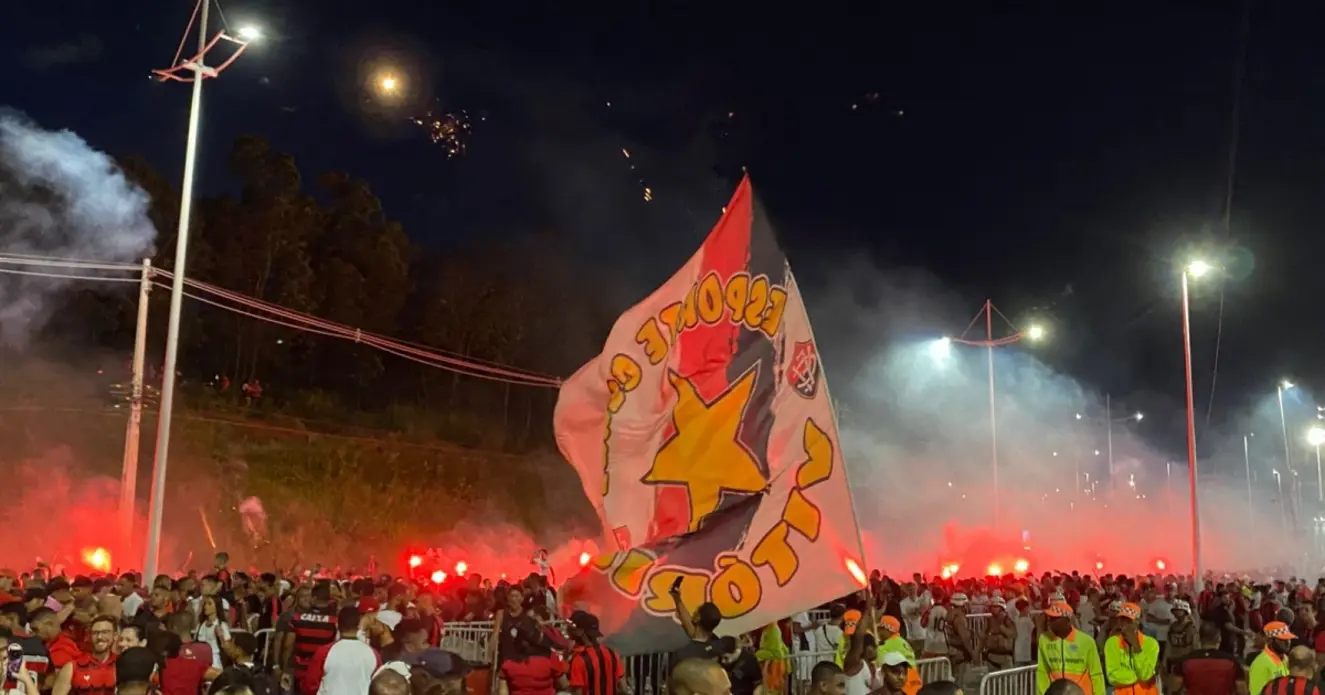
{"left": 42, "top": 136, "right": 613, "bottom": 450}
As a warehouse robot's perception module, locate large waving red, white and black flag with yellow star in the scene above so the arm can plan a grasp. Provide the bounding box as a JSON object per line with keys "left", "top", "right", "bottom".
{"left": 554, "top": 179, "right": 865, "bottom": 654}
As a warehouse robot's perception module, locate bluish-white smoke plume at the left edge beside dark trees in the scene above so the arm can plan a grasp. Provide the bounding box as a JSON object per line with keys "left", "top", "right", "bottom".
{"left": 0, "top": 110, "right": 156, "bottom": 346}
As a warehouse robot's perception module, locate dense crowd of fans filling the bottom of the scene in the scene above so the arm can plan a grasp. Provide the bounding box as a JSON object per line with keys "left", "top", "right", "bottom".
{"left": 0, "top": 553, "right": 1325, "bottom": 695}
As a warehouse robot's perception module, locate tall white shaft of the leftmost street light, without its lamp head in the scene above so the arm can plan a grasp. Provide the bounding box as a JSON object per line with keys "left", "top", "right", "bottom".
{"left": 143, "top": 1, "right": 211, "bottom": 577}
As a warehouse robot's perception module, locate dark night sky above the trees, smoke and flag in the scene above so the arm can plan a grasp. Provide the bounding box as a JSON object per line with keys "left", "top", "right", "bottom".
{"left": 0, "top": 0, "right": 1325, "bottom": 450}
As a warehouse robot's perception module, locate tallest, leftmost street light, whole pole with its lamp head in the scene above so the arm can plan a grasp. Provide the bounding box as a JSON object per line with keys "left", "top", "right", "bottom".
{"left": 143, "top": 0, "right": 262, "bottom": 577}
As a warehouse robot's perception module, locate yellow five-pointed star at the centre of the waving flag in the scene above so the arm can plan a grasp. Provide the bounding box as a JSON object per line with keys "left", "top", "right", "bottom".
{"left": 643, "top": 368, "right": 769, "bottom": 531}
